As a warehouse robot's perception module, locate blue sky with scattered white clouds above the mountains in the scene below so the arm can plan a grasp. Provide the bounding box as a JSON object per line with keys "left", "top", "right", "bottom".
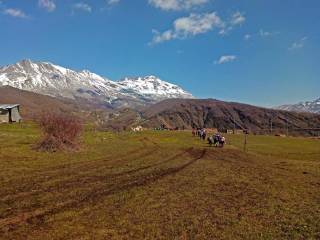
{"left": 0, "top": 0, "right": 320, "bottom": 106}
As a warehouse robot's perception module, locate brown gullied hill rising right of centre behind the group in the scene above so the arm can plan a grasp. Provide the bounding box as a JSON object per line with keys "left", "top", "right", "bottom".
{"left": 105, "top": 99, "right": 320, "bottom": 133}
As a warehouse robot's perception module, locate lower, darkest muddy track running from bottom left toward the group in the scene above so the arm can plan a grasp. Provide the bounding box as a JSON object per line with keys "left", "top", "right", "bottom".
{"left": 0, "top": 149, "right": 207, "bottom": 233}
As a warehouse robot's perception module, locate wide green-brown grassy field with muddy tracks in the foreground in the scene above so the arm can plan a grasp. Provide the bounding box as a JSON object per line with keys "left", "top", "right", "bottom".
{"left": 0, "top": 124, "right": 320, "bottom": 239}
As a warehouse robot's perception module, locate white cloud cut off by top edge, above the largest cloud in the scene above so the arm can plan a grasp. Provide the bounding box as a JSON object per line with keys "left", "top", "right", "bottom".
{"left": 149, "top": 0, "right": 209, "bottom": 11}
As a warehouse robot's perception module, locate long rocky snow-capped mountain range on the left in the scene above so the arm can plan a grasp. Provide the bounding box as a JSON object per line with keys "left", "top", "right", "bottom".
{"left": 0, "top": 60, "right": 193, "bottom": 106}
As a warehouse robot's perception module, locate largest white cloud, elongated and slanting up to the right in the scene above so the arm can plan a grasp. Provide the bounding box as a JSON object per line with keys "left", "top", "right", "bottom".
{"left": 151, "top": 12, "right": 224, "bottom": 44}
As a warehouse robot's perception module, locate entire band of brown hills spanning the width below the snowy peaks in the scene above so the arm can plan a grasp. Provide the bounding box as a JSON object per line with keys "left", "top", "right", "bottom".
{"left": 0, "top": 86, "right": 320, "bottom": 135}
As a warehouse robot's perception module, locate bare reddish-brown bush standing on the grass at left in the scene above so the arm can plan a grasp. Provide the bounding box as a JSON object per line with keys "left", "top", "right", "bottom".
{"left": 36, "top": 113, "right": 82, "bottom": 152}
